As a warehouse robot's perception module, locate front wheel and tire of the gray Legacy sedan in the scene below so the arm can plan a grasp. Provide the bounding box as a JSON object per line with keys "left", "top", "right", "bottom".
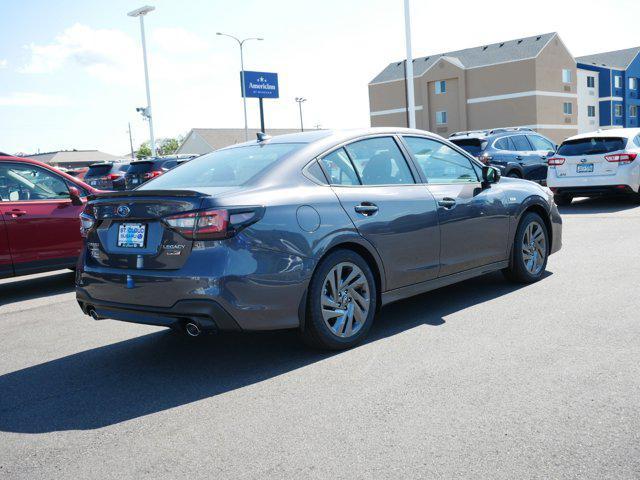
{"left": 502, "top": 212, "right": 550, "bottom": 283}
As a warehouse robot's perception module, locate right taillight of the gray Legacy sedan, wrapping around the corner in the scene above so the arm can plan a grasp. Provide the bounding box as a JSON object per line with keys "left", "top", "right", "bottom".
{"left": 164, "top": 207, "right": 264, "bottom": 240}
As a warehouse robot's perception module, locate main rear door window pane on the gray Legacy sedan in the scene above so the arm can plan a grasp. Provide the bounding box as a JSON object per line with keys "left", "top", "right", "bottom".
{"left": 345, "top": 137, "right": 415, "bottom": 185}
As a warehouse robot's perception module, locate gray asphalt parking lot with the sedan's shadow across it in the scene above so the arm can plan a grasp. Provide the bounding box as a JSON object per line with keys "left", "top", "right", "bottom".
{"left": 0, "top": 200, "right": 640, "bottom": 479}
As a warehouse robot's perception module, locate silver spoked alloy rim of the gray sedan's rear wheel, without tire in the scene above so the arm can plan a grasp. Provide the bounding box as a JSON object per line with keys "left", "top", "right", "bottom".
{"left": 320, "top": 262, "right": 371, "bottom": 338}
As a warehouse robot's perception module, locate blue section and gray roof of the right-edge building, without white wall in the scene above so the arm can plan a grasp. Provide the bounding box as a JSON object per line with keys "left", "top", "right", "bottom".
{"left": 576, "top": 47, "right": 640, "bottom": 128}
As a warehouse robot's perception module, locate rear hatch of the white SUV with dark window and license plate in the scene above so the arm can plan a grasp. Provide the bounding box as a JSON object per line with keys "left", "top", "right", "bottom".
{"left": 554, "top": 137, "right": 627, "bottom": 180}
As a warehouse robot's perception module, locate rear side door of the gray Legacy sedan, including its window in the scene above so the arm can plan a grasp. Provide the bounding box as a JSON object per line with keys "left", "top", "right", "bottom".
{"left": 320, "top": 136, "right": 440, "bottom": 290}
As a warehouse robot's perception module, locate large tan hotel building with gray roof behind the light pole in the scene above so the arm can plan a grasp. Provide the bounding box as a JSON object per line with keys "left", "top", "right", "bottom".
{"left": 369, "top": 33, "right": 578, "bottom": 143}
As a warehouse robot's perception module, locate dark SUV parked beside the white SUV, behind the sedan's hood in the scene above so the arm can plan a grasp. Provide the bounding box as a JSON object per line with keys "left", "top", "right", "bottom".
{"left": 449, "top": 127, "right": 557, "bottom": 183}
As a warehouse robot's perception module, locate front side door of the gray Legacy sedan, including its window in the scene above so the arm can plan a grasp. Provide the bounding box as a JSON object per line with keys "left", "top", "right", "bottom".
{"left": 403, "top": 136, "right": 509, "bottom": 276}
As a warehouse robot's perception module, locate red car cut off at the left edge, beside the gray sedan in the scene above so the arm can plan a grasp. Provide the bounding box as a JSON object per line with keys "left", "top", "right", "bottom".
{"left": 0, "top": 154, "right": 99, "bottom": 278}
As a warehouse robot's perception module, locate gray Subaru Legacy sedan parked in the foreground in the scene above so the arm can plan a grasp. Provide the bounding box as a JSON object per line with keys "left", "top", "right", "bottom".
{"left": 76, "top": 128, "right": 562, "bottom": 349}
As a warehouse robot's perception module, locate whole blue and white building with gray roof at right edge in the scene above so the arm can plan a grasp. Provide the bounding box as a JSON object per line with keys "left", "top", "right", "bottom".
{"left": 576, "top": 47, "right": 640, "bottom": 132}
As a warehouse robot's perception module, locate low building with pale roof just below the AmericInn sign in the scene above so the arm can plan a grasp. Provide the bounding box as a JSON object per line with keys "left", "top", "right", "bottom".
{"left": 176, "top": 128, "right": 300, "bottom": 155}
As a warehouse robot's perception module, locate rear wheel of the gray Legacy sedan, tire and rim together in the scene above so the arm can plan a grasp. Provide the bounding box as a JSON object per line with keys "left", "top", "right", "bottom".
{"left": 301, "top": 249, "right": 378, "bottom": 350}
